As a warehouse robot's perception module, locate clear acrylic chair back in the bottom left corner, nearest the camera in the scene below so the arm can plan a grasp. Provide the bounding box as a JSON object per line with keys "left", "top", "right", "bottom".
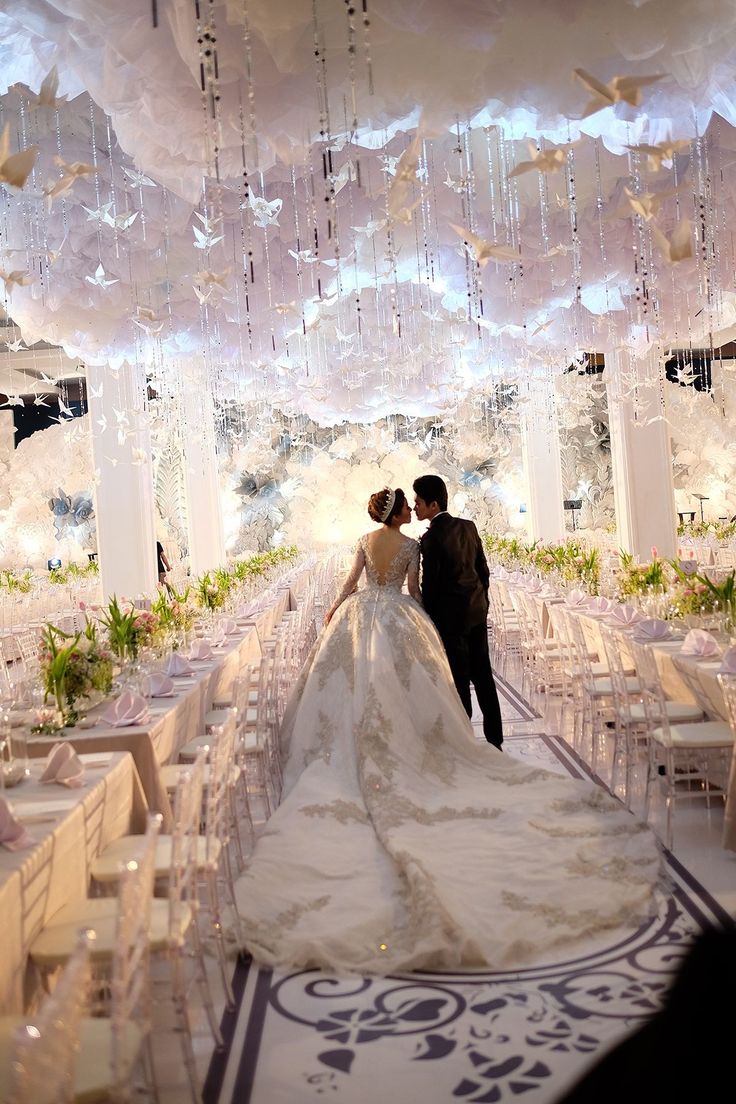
{"left": 7, "top": 932, "right": 90, "bottom": 1104}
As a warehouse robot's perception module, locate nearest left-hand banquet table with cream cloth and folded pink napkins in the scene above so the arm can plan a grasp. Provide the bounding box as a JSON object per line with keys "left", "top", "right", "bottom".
{"left": 0, "top": 752, "right": 147, "bottom": 1013}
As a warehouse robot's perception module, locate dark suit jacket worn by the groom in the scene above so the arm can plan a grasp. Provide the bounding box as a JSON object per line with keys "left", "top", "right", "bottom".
{"left": 419, "top": 513, "right": 489, "bottom": 635}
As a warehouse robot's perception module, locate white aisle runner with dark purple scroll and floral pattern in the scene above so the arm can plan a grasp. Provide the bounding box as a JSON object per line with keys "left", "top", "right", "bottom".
{"left": 204, "top": 734, "right": 727, "bottom": 1104}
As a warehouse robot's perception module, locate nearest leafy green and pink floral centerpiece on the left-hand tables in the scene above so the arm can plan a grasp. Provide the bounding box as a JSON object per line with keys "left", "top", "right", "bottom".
{"left": 34, "top": 620, "right": 113, "bottom": 731}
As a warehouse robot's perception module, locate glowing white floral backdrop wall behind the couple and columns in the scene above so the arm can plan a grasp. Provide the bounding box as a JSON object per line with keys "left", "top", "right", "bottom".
{"left": 0, "top": 372, "right": 736, "bottom": 567}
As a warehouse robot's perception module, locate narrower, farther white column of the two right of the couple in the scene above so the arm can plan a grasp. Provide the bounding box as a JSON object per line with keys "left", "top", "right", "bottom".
{"left": 521, "top": 373, "right": 565, "bottom": 543}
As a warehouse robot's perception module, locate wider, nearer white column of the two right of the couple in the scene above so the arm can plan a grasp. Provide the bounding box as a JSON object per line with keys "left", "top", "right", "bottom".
{"left": 606, "top": 349, "right": 676, "bottom": 561}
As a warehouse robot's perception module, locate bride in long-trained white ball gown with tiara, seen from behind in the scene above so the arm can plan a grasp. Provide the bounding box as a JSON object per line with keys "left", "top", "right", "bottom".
{"left": 237, "top": 489, "right": 660, "bottom": 973}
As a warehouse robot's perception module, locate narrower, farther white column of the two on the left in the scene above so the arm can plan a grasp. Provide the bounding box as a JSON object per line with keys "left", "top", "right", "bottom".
{"left": 181, "top": 376, "right": 225, "bottom": 575}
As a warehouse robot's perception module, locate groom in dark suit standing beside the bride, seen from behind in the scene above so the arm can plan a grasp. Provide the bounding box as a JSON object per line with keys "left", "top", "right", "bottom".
{"left": 414, "top": 476, "right": 503, "bottom": 747}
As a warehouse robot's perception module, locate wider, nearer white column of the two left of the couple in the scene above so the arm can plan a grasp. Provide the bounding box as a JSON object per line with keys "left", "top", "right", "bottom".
{"left": 87, "top": 364, "right": 158, "bottom": 599}
